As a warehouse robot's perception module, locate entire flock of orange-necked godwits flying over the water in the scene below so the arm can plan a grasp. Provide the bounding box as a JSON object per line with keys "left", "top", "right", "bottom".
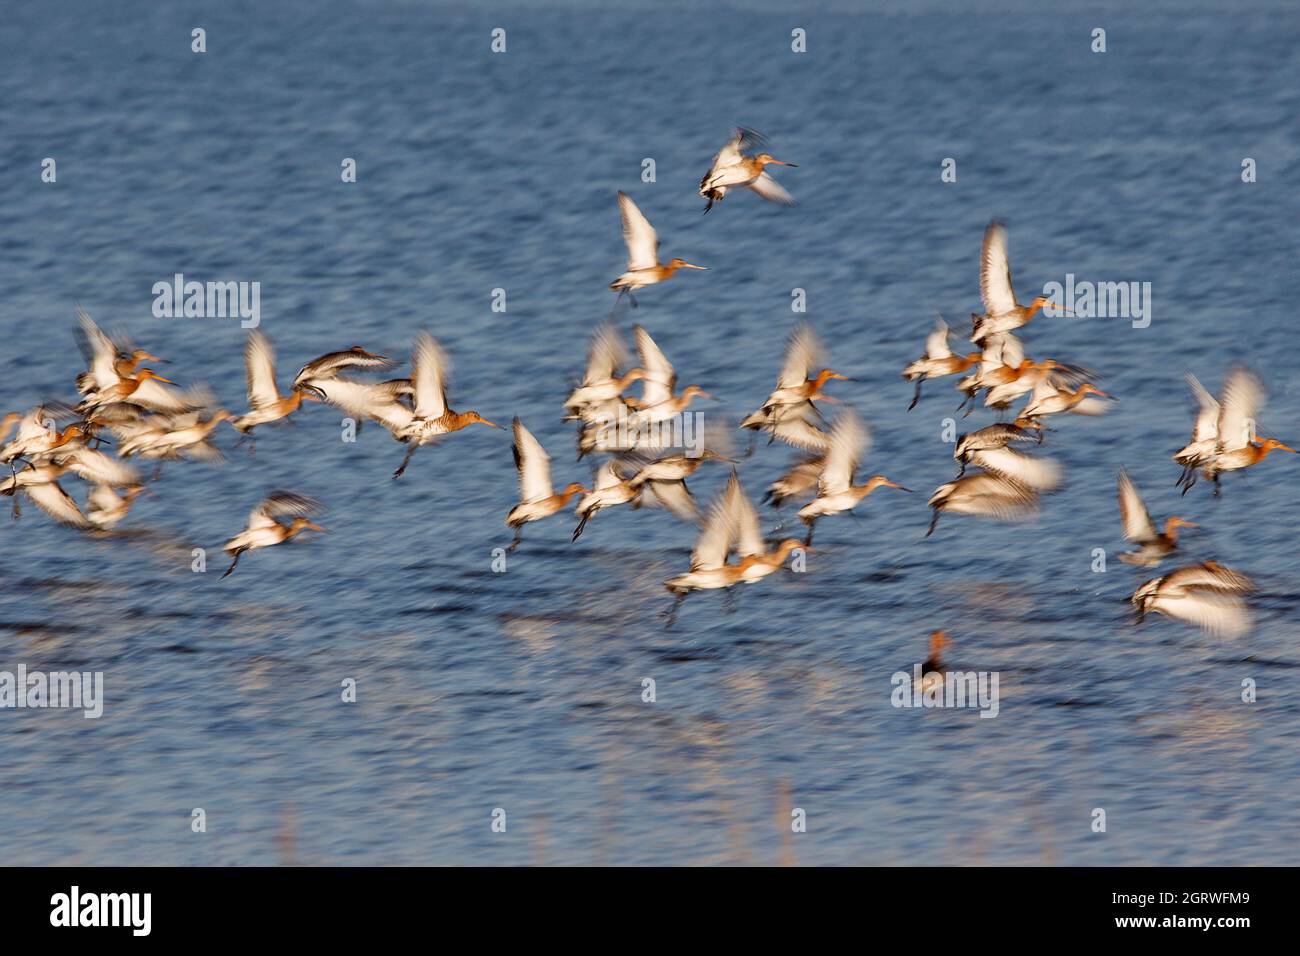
{"left": 0, "top": 129, "right": 1296, "bottom": 650}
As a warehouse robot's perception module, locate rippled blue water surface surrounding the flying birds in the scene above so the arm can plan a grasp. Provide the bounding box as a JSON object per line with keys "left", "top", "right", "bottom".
{"left": 0, "top": 0, "right": 1300, "bottom": 865}
